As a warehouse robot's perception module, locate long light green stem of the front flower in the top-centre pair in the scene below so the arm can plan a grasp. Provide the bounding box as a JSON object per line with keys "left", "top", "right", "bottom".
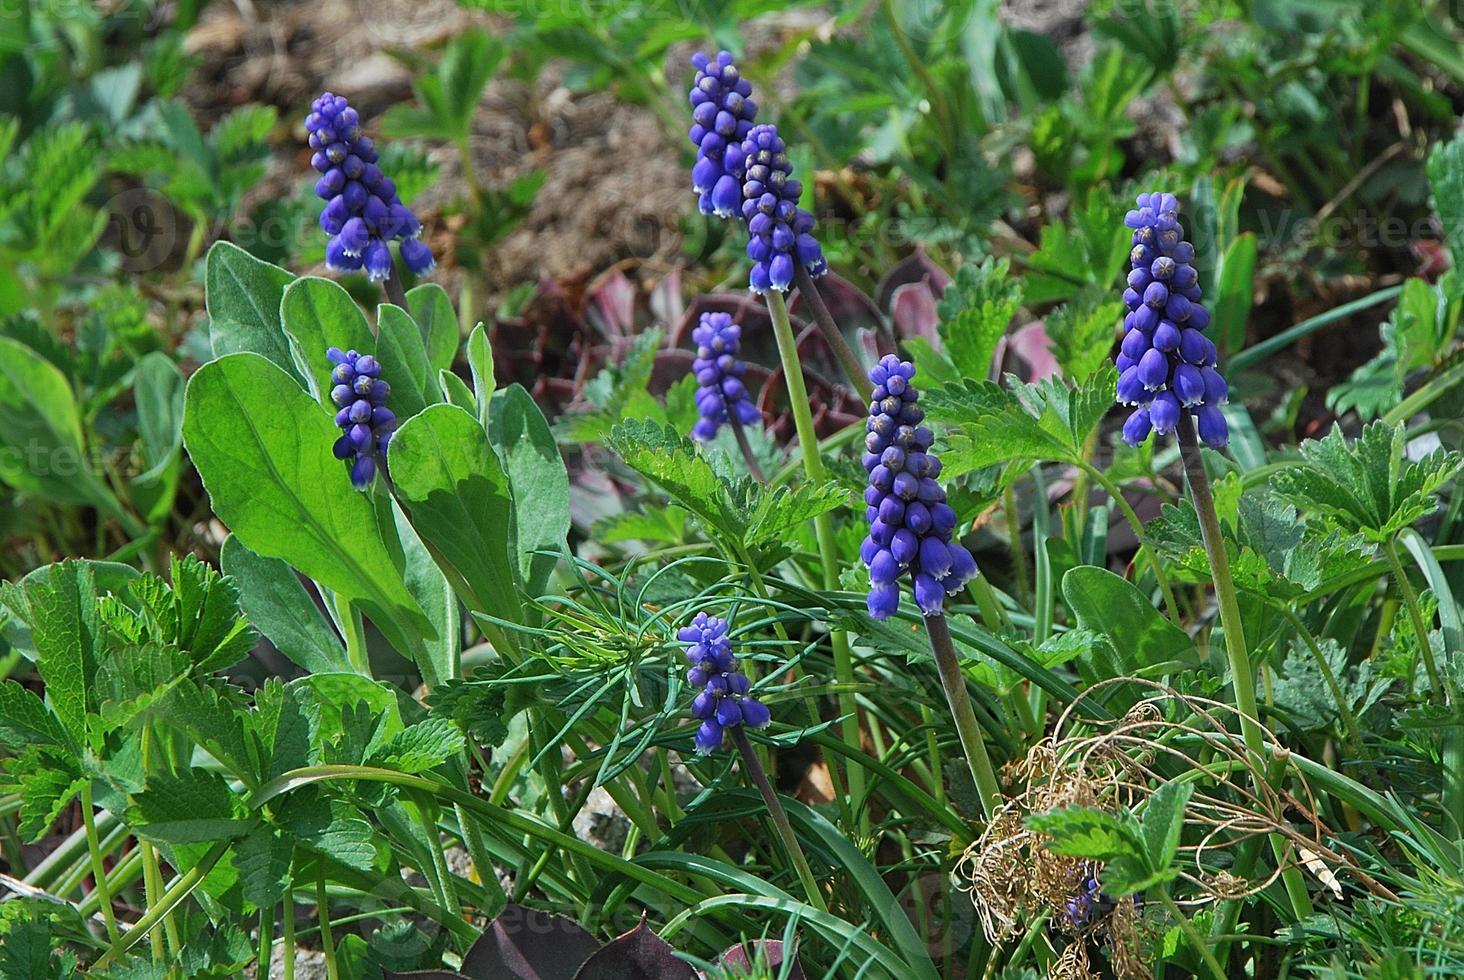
{"left": 767, "top": 290, "right": 864, "bottom": 820}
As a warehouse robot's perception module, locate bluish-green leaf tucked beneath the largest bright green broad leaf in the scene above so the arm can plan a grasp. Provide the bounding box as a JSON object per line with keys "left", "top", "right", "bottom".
{"left": 220, "top": 535, "right": 353, "bottom": 674}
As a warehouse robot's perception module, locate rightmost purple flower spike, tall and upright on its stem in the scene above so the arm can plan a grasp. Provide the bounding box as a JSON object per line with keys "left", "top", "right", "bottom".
{"left": 1117, "top": 193, "right": 1230, "bottom": 448}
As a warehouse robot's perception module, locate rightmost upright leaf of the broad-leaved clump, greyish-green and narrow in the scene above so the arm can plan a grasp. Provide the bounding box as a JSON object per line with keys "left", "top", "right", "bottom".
{"left": 488, "top": 384, "right": 569, "bottom": 596}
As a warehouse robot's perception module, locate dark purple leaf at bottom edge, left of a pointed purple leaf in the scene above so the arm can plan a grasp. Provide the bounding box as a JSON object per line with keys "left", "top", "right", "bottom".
{"left": 463, "top": 905, "right": 600, "bottom": 980}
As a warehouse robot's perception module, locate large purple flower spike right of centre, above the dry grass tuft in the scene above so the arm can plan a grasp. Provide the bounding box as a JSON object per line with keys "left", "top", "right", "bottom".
{"left": 859, "top": 354, "right": 976, "bottom": 620}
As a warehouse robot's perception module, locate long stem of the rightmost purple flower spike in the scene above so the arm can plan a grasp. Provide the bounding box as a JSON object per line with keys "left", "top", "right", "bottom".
{"left": 1179, "top": 412, "right": 1312, "bottom": 932}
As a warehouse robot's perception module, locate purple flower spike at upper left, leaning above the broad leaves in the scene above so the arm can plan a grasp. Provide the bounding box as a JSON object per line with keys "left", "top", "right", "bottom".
{"left": 305, "top": 92, "right": 433, "bottom": 283}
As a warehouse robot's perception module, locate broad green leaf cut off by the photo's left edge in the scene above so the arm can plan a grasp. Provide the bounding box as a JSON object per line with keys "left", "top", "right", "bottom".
{"left": 0, "top": 337, "right": 117, "bottom": 503}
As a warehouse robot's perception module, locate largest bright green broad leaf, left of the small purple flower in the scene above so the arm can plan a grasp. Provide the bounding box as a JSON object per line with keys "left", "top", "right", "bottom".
{"left": 183, "top": 347, "right": 432, "bottom": 649}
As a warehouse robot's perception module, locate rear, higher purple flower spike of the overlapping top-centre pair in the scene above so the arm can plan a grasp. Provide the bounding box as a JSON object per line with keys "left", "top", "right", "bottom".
{"left": 688, "top": 51, "right": 757, "bottom": 218}
